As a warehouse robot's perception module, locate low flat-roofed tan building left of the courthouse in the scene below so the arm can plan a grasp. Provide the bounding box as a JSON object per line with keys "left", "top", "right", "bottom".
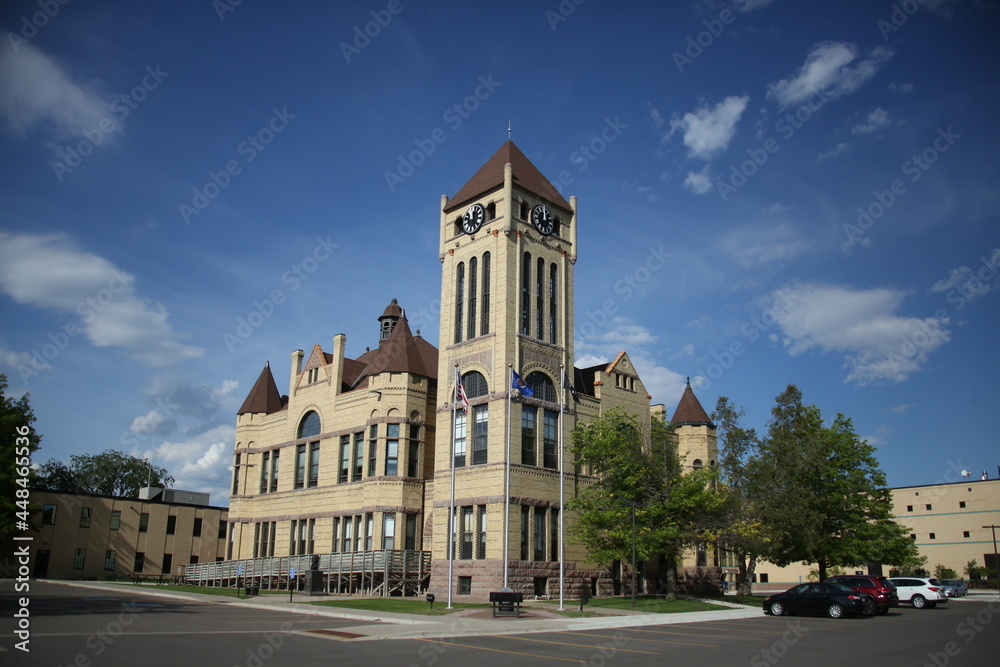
{"left": 23, "top": 489, "right": 228, "bottom": 579}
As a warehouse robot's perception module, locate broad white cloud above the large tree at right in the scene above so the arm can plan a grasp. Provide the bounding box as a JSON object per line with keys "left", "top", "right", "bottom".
{"left": 771, "top": 284, "right": 951, "bottom": 385}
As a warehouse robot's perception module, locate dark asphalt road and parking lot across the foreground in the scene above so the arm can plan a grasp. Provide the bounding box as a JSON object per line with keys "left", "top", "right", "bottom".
{"left": 0, "top": 580, "right": 1000, "bottom": 667}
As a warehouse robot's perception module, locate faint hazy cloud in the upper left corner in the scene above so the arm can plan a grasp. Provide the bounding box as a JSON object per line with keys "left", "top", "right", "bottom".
{"left": 0, "top": 43, "right": 109, "bottom": 139}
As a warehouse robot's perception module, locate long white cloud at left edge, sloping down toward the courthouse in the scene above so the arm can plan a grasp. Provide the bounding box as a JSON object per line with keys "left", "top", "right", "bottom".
{"left": 0, "top": 234, "right": 204, "bottom": 366}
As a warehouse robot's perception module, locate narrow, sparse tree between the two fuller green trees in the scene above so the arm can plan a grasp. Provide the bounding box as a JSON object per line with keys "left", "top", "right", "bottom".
{"left": 712, "top": 396, "right": 767, "bottom": 595}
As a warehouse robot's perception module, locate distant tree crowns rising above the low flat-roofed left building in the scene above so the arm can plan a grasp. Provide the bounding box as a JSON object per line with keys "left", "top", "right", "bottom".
{"left": 38, "top": 449, "right": 174, "bottom": 498}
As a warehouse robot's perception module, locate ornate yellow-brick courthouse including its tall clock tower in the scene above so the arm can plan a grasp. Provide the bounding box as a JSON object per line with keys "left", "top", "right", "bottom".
{"left": 223, "top": 141, "right": 716, "bottom": 596}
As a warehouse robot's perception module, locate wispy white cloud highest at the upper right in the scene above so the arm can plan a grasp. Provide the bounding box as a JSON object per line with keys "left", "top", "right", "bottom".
{"left": 767, "top": 42, "right": 892, "bottom": 109}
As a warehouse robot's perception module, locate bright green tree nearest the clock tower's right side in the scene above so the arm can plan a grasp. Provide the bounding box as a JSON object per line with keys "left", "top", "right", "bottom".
{"left": 568, "top": 408, "right": 726, "bottom": 596}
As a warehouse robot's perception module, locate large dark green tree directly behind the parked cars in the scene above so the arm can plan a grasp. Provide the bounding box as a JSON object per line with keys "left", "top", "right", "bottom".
{"left": 755, "top": 385, "right": 916, "bottom": 579}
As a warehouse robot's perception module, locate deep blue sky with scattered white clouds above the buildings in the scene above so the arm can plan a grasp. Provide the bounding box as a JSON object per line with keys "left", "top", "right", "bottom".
{"left": 0, "top": 0, "right": 1000, "bottom": 504}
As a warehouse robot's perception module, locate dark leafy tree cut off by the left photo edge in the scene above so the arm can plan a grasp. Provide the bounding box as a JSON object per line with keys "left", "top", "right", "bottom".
{"left": 0, "top": 373, "right": 42, "bottom": 553}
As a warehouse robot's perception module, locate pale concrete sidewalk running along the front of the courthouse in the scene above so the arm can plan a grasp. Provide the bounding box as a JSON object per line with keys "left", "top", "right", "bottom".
{"left": 50, "top": 581, "right": 763, "bottom": 641}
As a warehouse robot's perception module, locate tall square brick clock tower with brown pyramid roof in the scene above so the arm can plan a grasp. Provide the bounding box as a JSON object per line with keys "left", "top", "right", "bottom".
{"left": 427, "top": 140, "right": 577, "bottom": 596}
